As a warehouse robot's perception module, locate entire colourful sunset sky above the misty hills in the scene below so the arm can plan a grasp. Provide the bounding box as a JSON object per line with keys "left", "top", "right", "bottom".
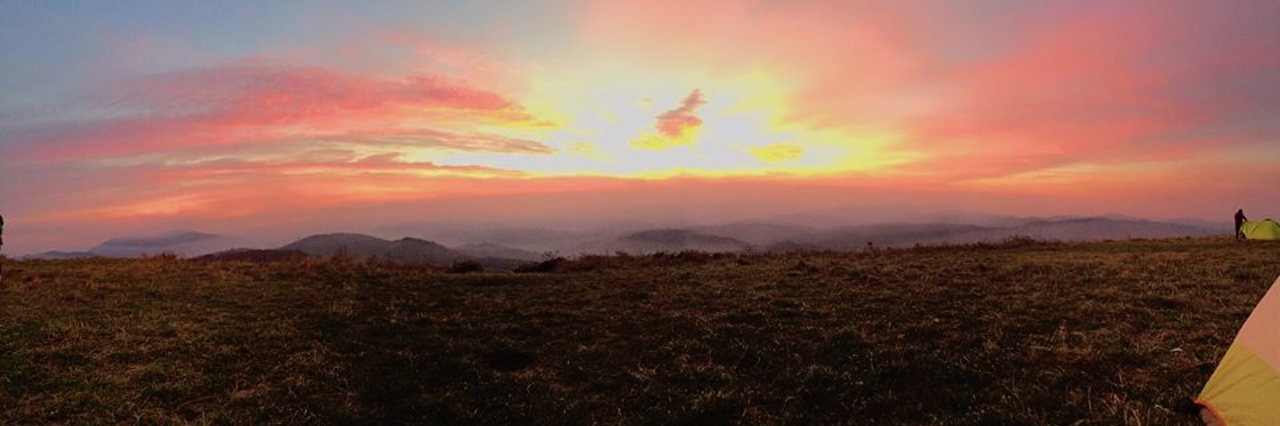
{"left": 0, "top": 0, "right": 1280, "bottom": 253}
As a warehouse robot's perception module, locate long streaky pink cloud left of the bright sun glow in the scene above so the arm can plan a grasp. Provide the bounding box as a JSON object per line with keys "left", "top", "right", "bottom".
{"left": 27, "top": 64, "right": 550, "bottom": 160}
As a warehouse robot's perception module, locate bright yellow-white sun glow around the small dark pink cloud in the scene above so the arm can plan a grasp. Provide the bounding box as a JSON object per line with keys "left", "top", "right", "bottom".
{"left": 432, "top": 65, "right": 915, "bottom": 178}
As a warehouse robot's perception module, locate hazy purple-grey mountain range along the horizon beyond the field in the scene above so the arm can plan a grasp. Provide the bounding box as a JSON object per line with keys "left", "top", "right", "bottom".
{"left": 17, "top": 217, "right": 1225, "bottom": 263}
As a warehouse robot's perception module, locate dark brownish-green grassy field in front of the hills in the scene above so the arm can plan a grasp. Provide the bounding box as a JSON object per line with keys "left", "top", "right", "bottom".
{"left": 0, "top": 239, "right": 1280, "bottom": 425}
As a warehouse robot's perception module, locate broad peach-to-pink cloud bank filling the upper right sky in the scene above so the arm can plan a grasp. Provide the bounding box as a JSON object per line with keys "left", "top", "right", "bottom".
{"left": 580, "top": 0, "right": 1280, "bottom": 182}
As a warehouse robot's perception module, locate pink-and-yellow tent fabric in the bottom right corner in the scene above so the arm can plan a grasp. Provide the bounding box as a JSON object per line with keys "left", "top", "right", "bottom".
{"left": 1197, "top": 273, "right": 1280, "bottom": 426}
